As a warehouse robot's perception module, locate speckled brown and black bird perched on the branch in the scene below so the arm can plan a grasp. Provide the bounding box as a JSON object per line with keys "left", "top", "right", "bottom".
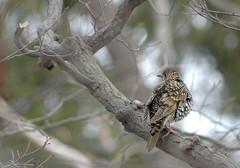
{"left": 144, "top": 68, "right": 193, "bottom": 151}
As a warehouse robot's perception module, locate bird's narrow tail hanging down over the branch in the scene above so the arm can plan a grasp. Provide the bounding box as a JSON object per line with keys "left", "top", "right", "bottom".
{"left": 146, "top": 120, "right": 164, "bottom": 152}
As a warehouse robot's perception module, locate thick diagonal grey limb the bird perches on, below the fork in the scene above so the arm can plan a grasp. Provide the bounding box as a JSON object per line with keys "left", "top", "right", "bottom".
{"left": 52, "top": 38, "right": 239, "bottom": 168}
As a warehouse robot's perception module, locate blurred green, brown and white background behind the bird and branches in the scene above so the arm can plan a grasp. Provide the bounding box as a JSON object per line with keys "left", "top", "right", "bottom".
{"left": 0, "top": 0, "right": 240, "bottom": 168}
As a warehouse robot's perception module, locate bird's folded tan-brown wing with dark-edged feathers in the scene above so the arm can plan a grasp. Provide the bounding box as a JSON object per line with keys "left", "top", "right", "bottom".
{"left": 151, "top": 80, "right": 187, "bottom": 123}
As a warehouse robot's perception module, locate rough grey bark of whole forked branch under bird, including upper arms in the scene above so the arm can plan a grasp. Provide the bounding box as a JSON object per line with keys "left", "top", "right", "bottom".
{"left": 11, "top": 0, "right": 239, "bottom": 168}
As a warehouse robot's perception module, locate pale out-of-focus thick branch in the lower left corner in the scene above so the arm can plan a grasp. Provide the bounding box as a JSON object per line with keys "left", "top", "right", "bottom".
{"left": 0, "top": 97, "right": 93, "bottom": 168}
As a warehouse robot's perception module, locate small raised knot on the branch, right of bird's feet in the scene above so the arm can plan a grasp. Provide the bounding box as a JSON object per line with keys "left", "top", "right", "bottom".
{"left": 179, "top": 136, "right": 200, "bottom": 153}
